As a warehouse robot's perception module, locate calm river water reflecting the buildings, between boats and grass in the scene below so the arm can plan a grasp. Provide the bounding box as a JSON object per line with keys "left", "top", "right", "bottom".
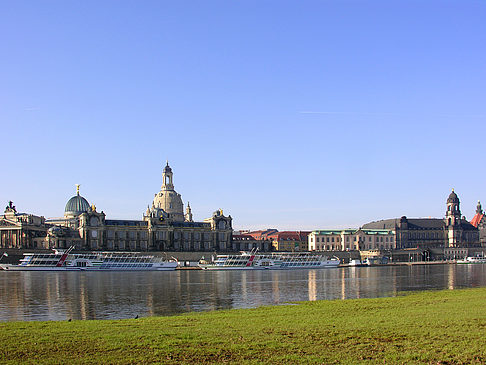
{"left": 0, "top": 264, "right": 486, "bottom": 321}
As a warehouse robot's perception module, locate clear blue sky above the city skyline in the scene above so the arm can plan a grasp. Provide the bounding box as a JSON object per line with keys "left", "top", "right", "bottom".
{"left": 0, "top": 0, "right": 486, "bottom": 230}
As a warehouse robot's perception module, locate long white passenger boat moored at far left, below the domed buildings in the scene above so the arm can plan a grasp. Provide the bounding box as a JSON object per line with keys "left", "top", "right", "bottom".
{"left": 0, "top": 246, "right": 178, "bottom": 271}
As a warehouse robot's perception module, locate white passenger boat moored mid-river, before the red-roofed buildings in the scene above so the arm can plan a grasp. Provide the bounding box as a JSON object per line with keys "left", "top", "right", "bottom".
{"left": 199, "top": 251, "right": 340, "bottom": 270}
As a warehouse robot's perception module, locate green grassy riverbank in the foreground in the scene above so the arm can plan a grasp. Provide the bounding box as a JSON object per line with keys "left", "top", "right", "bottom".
{"left": 0, "top": 288, "right": 486, "bottom": 364}
